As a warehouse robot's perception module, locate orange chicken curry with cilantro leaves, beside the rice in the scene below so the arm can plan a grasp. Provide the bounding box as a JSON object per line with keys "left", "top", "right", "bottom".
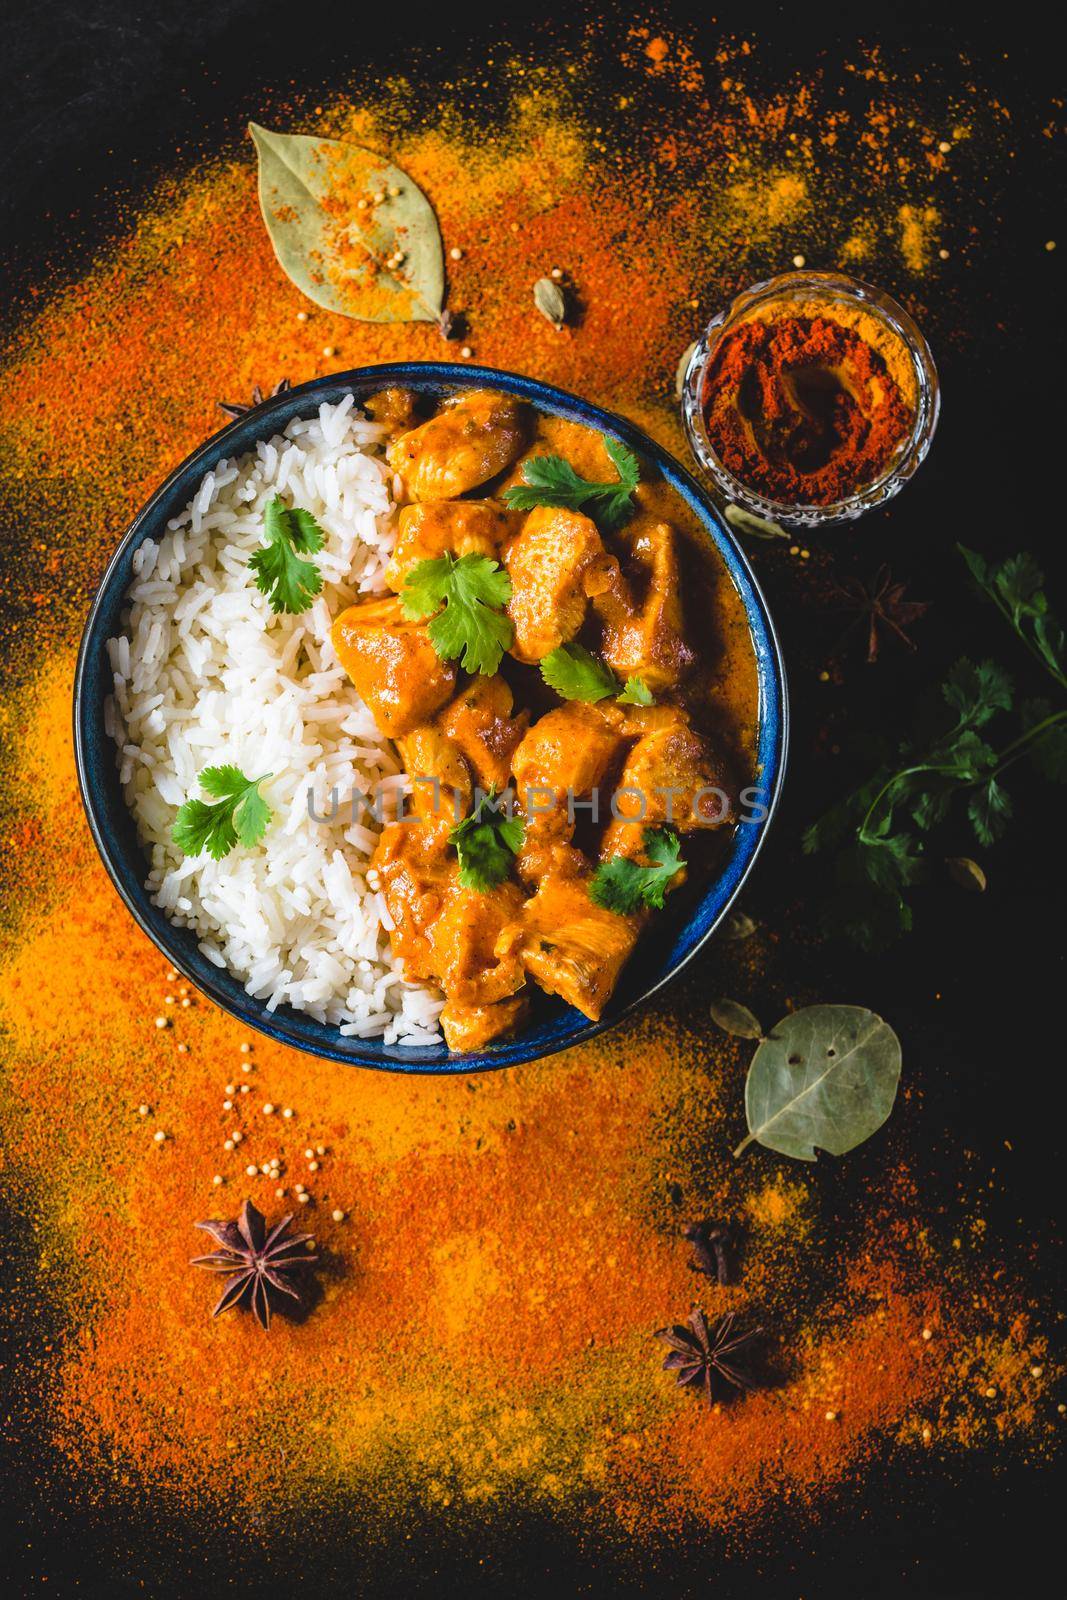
{"left": 333, "top": 389, "right": 757, "bottom": 1051}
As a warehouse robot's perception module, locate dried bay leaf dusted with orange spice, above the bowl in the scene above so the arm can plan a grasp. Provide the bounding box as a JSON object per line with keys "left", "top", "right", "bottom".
{"left": 248, "top": 122, "right": 445, "bottom": 322}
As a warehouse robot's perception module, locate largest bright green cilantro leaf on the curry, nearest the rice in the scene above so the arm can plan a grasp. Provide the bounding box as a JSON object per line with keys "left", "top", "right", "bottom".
{"left": 400, "top": 554, "right": 515, "bottom": 677}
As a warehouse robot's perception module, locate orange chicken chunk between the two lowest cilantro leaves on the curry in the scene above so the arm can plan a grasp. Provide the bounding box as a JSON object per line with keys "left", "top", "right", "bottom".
{"left": 512, "top": 701, "right": 624, "bottom": 883}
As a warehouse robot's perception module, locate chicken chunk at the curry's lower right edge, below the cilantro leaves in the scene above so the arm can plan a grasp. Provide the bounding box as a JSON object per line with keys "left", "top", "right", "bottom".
{"left": 523, "top": 875, "right": 640, "bottom": 1022}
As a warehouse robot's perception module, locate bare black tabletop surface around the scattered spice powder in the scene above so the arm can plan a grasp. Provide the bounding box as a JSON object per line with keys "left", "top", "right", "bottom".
{"left": 0, "top": 0, "right": 1067, "bottom": 1600}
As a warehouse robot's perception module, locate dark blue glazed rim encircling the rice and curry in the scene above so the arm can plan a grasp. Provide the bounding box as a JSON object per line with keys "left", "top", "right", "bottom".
{"left": 72, "top": 362, "right": 790, "bottom": 1075}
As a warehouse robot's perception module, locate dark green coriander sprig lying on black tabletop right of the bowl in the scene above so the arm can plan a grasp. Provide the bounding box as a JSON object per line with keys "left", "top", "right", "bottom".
{"left": 803, "top": 547, "right": 1067, "bottom": 949}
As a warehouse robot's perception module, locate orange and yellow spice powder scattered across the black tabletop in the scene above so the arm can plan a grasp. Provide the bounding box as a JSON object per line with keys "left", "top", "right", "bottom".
{"left": 0, "top": 32, "right": 1057, "bottom": 1536}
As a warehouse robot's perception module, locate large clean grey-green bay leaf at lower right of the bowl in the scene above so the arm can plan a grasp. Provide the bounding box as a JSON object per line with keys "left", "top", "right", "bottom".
{"left": 734, "top": 1005, "right": 901, "bottom": 1162}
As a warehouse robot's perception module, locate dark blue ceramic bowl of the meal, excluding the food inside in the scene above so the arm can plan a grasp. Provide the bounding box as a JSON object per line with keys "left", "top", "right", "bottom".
{"left": 74, "top": 362, "right": 789, "bottom": 1072}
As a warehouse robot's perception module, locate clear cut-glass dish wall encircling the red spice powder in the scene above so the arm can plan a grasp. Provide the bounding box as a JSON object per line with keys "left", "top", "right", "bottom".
{"left": 681, "top": 272, "right": 941, "bottom": 528}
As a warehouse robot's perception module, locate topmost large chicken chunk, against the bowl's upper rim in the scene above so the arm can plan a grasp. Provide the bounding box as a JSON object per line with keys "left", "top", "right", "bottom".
{"left": 387, "top": 389, "right": 530, "bottom": 501}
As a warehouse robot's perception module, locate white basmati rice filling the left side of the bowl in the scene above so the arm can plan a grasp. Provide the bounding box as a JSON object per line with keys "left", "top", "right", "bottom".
{"left": 106, "top": 395, "right": 443, "bottom": 1045}
